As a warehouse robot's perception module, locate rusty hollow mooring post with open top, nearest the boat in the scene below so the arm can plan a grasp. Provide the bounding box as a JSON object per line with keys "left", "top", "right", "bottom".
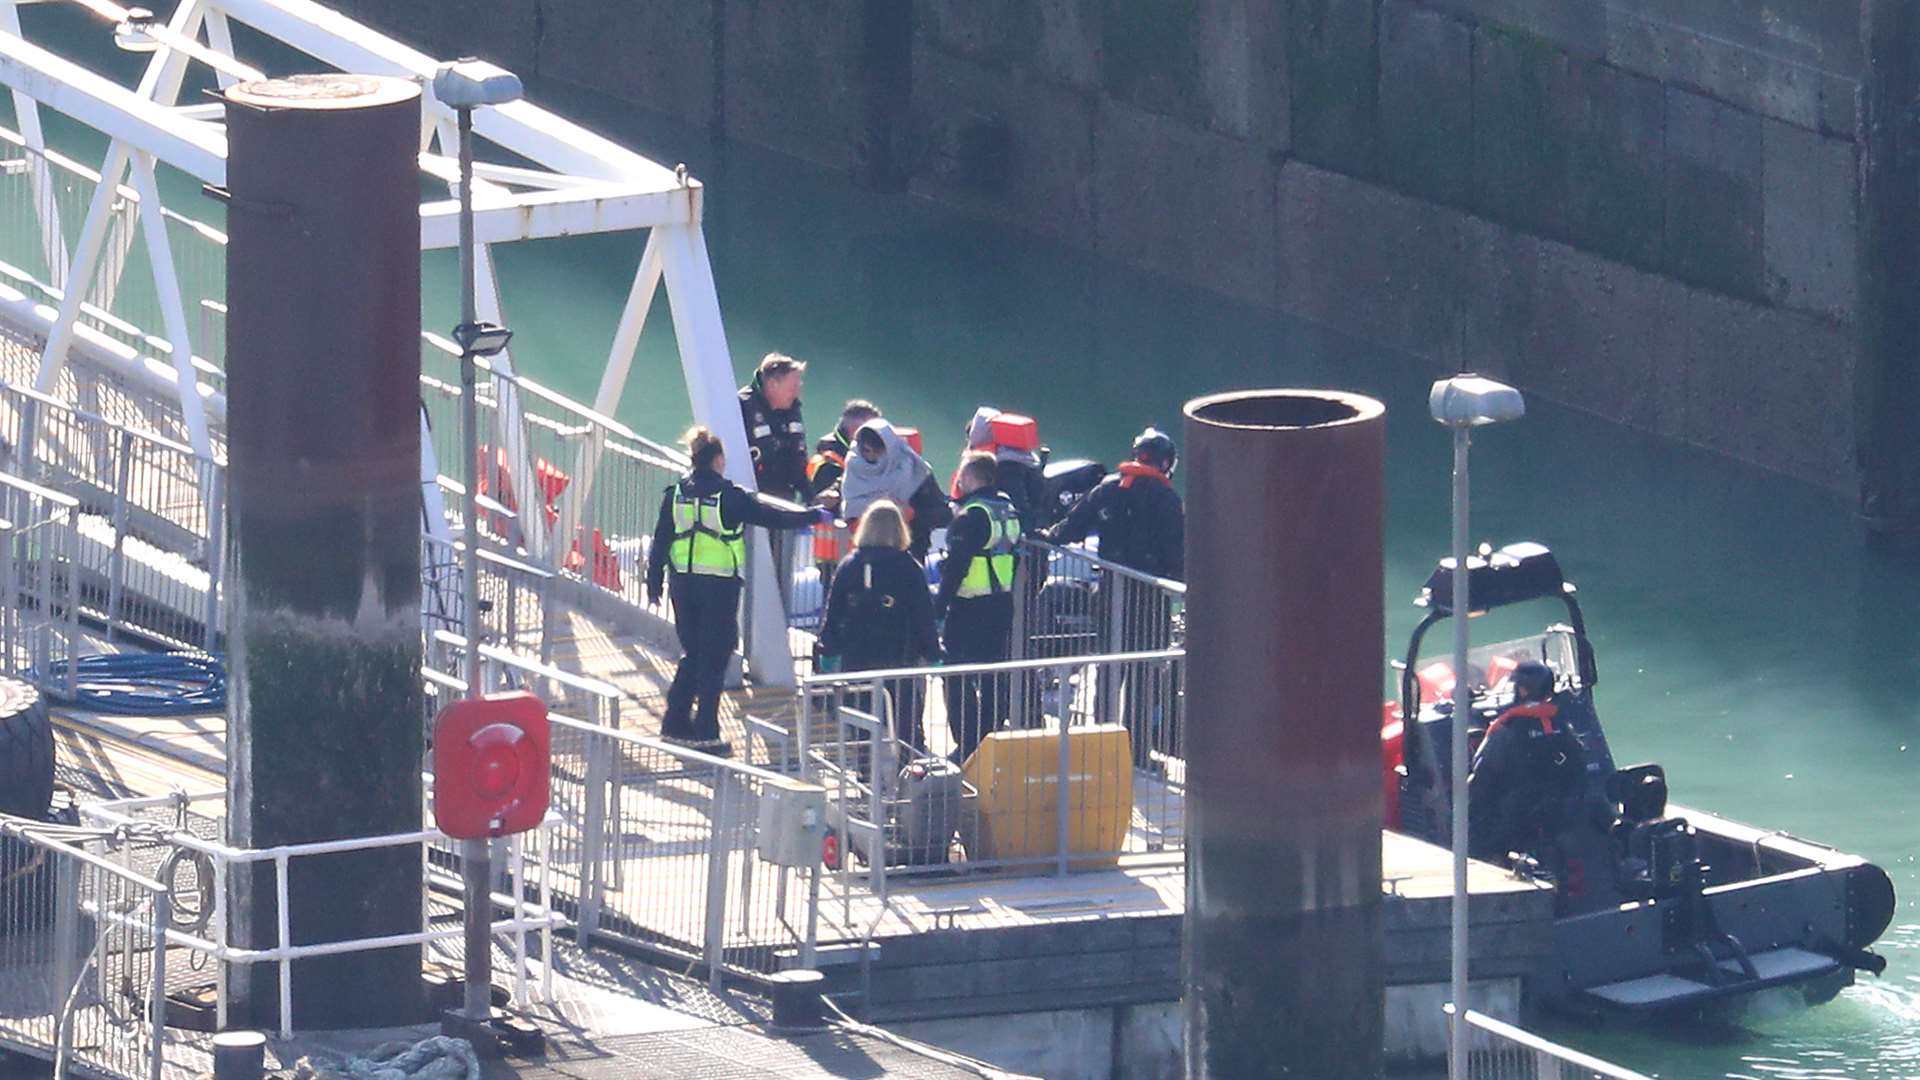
{"left": 1183, "top": 390, "right": 1386, "bottom": 1080}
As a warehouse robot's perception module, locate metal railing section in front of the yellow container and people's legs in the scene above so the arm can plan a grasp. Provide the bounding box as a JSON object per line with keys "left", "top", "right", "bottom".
{"left": 791, "top": 650, "right": 1187, "bottom": 896}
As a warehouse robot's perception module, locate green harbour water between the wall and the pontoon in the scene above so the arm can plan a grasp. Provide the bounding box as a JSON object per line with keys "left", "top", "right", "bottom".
{"left": 15, "top": 6, "right": 1920, "bottom": 1078}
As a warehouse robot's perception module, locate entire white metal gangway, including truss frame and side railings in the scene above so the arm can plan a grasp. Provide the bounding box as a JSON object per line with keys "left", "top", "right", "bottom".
{"left": 0, "top": 0, "right": 793, "bottom": 684}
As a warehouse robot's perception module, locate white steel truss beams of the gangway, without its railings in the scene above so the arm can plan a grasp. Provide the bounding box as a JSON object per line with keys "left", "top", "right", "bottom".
{"left": 0, "top": 0, "right": 793, "bottom": 684}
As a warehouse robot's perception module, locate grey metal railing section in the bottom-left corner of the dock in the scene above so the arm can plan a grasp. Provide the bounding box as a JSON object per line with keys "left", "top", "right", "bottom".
{"left": 0, "top": 819, "right": 177, "bottom": 1080}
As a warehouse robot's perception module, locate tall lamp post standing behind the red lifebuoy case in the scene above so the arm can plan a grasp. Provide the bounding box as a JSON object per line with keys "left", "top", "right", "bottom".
{"left": 434, "top": 60, "right": 522, "bottom": 1045}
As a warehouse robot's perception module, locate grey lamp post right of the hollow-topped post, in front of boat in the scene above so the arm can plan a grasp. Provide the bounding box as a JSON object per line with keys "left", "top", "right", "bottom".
{"left": 1427, "top": 373, "right": 1526, "bottom": 1080}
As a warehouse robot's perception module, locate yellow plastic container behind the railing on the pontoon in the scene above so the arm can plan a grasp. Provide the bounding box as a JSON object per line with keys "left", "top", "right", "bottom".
{"left": 966, "top": 724, "right": 1133, "bottom": 865}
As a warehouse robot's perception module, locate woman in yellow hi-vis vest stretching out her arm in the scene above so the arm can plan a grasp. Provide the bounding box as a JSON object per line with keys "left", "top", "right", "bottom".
{"left": 647, "top": 427, "right": 833, "bottom": 755}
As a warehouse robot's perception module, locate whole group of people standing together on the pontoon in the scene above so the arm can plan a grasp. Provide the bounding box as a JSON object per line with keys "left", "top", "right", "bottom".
{"left": 647, "top": 354, "right": 1185, "bottom": 761}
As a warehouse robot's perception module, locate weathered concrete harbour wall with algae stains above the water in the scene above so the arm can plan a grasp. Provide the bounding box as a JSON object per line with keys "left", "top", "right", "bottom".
{"left": 336, "top": 0, "right": 1920, "bottom": 511}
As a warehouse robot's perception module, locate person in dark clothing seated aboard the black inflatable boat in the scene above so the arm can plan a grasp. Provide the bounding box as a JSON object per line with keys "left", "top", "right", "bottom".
{"left": 1467, "top": 661, "right": 1586, "bottom": 865}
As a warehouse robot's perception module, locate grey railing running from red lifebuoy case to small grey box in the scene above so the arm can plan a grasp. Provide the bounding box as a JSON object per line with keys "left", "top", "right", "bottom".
{"left": 428, "top": 632, "right": 826, "bottom": 986}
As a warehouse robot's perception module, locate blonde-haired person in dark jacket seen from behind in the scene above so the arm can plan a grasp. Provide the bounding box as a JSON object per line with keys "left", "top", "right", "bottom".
{"left": 820, "top": 500, "right": 941, "bottom": 753}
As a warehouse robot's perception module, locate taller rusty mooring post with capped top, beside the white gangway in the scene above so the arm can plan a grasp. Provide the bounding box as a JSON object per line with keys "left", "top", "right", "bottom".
{"left": 227, "top": 75, "right": 426, "bottom": 1028}
